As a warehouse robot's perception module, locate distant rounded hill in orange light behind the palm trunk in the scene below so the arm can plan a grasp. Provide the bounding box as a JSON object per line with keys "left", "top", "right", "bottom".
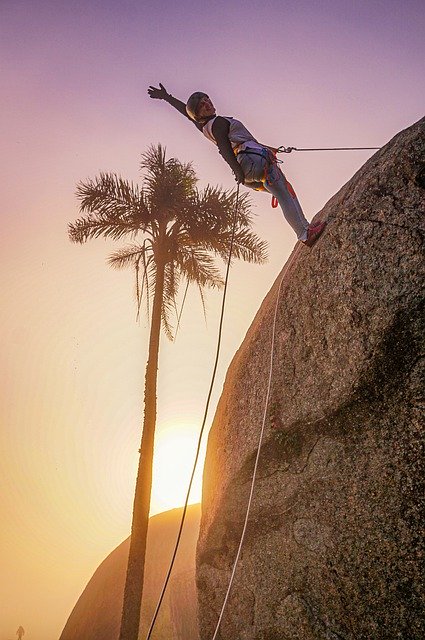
{"left": 59, "top": 504, "right": 201, "bottom": 640}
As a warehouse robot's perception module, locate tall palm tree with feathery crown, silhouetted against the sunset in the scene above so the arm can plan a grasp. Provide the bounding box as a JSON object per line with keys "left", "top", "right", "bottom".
{"left": 69, "top": 145, "right": 266, "bottom": 640}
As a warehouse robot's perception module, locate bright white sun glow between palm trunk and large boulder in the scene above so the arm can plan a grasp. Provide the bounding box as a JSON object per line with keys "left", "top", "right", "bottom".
{"left": 151, "top": 425, "right": 205, "bottom": 515}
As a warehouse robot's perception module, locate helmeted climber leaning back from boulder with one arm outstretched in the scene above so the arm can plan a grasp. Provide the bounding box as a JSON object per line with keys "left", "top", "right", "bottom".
{"left": 148, "top": 83, "right": 326, "bottom": 247}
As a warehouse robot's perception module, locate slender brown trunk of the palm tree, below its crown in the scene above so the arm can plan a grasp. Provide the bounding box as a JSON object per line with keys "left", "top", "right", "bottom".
{"left": 120, "top": 260, "right": 165, "bottom": 640}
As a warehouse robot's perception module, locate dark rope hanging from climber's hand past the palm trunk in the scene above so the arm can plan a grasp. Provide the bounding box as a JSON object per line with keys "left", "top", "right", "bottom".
{"left": 146, "top": 183, "right": 240, "bottom": 640}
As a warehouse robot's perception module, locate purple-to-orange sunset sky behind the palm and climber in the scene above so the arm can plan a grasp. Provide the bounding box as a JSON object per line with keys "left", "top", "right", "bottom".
{"left": 0, "top": 0, "right": 425, "bottom": 640}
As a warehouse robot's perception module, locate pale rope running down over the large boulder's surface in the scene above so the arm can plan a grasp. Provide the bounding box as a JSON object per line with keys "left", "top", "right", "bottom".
{"left": 212, "top": 242, "right": 298, "bottom": 640}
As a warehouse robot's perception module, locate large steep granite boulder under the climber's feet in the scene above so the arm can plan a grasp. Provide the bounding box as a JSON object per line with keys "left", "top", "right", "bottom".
{"left": 197, "top": 118, "right": 425, "bottom": 640}
